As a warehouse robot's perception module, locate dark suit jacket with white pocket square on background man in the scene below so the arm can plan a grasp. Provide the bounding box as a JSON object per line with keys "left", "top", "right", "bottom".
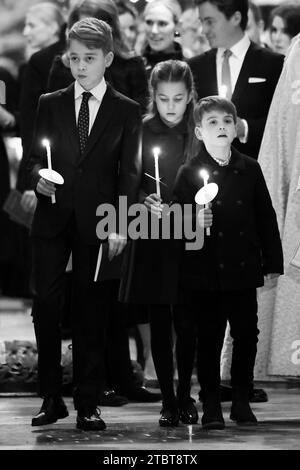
{"left": 188, "top": 43, "right": 284, "bottom": 158}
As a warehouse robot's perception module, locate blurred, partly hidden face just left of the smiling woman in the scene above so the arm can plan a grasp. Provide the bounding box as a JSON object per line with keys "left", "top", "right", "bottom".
{"left": 116, "top": 0, "right": 139, "bottom": 51}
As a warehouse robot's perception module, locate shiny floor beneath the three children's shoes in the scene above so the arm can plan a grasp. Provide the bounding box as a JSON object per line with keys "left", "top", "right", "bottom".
{"left": 0, "top": 389, "right": 300, "bottom": 452}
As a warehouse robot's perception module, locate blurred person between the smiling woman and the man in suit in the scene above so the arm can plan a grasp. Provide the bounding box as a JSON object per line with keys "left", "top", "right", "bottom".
{"left": 179, "top": 7, "right": 210, "bottom": 59}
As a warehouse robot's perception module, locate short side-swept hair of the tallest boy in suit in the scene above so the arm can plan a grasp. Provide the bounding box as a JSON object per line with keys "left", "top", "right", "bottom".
{"left": 68, "top": 18, "right": 114, "bottom": 54}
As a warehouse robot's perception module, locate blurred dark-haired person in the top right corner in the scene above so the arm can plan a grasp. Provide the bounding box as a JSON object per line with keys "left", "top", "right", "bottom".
{"left": 269, "top": 2, "right": 300, "bottom": 55}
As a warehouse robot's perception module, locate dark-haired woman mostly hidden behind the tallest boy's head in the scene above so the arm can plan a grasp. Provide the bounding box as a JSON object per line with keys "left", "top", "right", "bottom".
{"left": 48, "top": 0, "right": 148, "bottom": 111}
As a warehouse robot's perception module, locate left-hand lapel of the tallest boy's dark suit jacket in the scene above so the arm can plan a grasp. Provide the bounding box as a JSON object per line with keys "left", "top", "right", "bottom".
{"left": 60, "top": 83, "right": 80, "bottom": 161}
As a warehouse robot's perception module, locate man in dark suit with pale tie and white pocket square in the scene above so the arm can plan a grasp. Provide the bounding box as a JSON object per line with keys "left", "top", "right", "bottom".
{"left": 189, "top": 0, "right": 284, "bottom": 158}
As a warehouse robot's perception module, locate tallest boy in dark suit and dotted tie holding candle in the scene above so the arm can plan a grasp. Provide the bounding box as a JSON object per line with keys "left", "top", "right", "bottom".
{"left": 28, "top": 18, "right": 141, "bottom": 431}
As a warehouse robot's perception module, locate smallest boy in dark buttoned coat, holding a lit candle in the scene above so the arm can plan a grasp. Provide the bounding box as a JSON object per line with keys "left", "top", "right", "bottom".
{"left": 174, "top": 96, "right": 283, "bottom": 429}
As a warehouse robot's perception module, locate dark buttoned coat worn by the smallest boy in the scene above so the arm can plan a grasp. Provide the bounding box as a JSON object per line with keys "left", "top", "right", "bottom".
{"left": 174, "top": 145, "right": 283, "bottom": 291}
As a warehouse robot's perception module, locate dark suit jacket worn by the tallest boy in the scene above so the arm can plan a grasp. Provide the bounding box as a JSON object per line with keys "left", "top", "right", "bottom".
{"left": 28, "top": 84, "right": 142, "bottom": 245}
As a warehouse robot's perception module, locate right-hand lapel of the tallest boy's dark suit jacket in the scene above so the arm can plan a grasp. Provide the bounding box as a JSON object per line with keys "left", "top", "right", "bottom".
{"left": 78, "top": 85, "right": 114, "bottom": 164}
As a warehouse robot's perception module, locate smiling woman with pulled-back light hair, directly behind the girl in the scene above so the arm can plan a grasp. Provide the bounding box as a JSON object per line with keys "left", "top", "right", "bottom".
{"left": 143, "top": 0, "right": 183, "bottom": 77}
